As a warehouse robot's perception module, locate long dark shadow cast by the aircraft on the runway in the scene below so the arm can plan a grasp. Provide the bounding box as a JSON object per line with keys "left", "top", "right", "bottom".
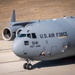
{"left": 33, "top": 56, "right": 75, "bottom": 69}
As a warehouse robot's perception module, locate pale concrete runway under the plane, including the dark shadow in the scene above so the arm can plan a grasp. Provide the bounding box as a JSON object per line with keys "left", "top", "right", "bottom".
{"left": 0, "top": 40, "right": 75, "bottom": 75}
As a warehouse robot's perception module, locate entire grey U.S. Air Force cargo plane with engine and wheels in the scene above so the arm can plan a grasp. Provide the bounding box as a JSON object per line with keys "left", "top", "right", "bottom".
{"left": 2, "top": 10, "right": 75, "bottom": 70}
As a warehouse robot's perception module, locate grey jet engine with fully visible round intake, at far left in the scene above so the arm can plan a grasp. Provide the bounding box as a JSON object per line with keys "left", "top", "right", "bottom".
{"left": 2, "top": 26, "right": 22, "bottom": 41}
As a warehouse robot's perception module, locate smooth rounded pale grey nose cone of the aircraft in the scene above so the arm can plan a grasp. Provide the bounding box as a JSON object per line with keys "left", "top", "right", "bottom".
{"left": 12, "top": 39, "right": 23, "bottom": 57}
